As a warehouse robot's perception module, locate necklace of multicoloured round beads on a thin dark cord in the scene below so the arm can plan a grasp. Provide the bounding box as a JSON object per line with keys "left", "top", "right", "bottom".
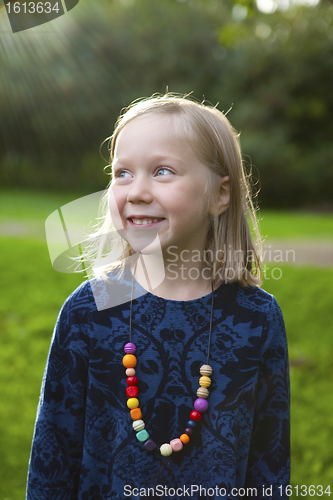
{"left": 123, "top": 266, "right": 214, "bottom": 457}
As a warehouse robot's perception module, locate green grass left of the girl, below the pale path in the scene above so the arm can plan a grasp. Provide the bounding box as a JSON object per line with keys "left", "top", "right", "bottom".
{"left": 0, "top": 239, "right": 82, "bottom": 500}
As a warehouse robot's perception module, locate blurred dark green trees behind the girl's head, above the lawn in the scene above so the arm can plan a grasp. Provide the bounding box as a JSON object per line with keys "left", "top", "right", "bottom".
{"left": 0, "top": 0, "right": 333, "bottom": 207}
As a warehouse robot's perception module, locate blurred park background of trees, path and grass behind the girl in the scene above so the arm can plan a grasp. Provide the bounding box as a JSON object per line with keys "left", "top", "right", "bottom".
{"left": 0, "top": 0, "right": 333, "bottom": 500}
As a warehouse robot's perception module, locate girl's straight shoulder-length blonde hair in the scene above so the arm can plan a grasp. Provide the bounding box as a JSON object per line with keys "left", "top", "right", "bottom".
{"left": 81, "top": 93, "right": 261, "bottom": 286}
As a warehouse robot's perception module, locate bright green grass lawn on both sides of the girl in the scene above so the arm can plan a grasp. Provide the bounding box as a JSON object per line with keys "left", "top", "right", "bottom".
{"left": 0, "top": 189, "right": 333, "bottom": 500}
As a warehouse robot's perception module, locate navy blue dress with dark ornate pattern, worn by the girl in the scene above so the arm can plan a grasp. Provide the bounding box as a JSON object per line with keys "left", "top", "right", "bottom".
{"left": 27, "top": 274, "right": 290, "bottom": 500}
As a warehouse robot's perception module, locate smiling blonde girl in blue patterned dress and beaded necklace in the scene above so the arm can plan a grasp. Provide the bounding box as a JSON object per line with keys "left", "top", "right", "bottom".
{"left": 27, "top": 94, "right": 289, "bottom": 500}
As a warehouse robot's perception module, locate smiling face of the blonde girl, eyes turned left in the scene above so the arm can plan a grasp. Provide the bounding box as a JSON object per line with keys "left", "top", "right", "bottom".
{"left": 109, "top": 114, "right": 211, "bottom": 259}
